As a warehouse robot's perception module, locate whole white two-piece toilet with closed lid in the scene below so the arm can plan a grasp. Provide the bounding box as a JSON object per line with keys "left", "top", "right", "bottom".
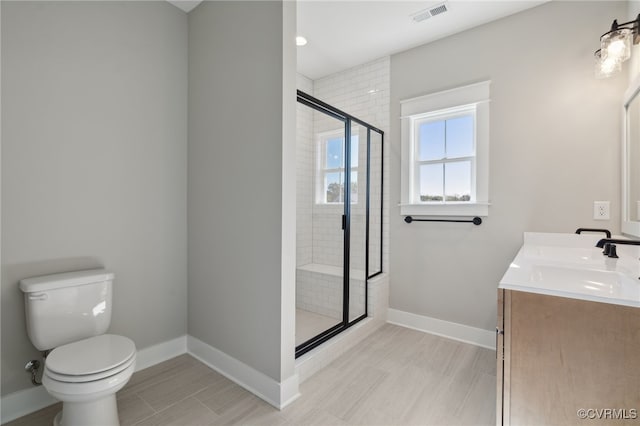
{"left": 20, "top": 269, "right": 136, "bottom": 426}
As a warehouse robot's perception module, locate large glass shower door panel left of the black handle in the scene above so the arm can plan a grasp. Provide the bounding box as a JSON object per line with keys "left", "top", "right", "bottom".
{"left": 296, "top": 104, "right": 350, "bottom": 351}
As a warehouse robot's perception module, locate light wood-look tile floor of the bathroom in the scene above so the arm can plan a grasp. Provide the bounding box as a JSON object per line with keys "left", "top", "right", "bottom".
{"left": 6, "top": 324, "right": 496, "bottom": 426}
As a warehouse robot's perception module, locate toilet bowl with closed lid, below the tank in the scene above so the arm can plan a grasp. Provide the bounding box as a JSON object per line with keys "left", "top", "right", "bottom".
{"left": 42, "top": 334, "right": 136, "bottom": 426}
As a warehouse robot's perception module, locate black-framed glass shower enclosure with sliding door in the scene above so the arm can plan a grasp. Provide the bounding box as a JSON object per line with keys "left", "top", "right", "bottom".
{"left": 296, "top": 91, "right": 384, "bottom": 357}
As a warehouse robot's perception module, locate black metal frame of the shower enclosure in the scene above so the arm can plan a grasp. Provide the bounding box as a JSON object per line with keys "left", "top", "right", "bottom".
{"left": 295, "top": 90, "right": 384, "bottom": 358}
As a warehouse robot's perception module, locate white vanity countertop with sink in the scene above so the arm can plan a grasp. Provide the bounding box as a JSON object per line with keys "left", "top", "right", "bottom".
{"left": 499, "top": 232, "right": 640, "bottom": 307}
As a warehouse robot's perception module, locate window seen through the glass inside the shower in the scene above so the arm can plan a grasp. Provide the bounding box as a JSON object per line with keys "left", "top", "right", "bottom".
{"left": 316, "top": 130, "right": 359, "bottom": 204}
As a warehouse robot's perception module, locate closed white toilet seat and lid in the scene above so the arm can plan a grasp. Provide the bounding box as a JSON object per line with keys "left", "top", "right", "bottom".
{"left": 44, "top": 334, "right": 136, "bottom": 383}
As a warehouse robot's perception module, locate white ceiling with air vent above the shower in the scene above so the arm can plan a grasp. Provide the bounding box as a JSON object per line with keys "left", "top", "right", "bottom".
{"left": 297, "top": 0, "right": 547, "bottom": 80}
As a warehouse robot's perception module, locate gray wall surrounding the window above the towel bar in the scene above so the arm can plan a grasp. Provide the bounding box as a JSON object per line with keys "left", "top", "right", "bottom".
{"left": 390, "top": 1, "right": 627, "bottom": 330}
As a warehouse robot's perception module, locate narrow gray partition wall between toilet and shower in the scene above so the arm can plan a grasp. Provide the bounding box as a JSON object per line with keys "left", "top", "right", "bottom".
{"left": 188, "top": 1, "right": 284, "bottom": 381}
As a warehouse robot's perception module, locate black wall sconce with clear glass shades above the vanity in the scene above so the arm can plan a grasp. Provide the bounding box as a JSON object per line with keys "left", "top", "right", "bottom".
{"left": 594, "top": 14, "right": 640, "bottom": 78}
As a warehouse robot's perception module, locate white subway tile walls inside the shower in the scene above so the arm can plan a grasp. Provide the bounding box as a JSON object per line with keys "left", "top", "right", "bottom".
{"left": 296, "top": 57, "right": 390, "bottom": 319}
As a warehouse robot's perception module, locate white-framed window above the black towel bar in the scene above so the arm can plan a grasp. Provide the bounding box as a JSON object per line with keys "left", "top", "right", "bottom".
{"left": 400, "top": 82, "right": 490, "bottom": 216}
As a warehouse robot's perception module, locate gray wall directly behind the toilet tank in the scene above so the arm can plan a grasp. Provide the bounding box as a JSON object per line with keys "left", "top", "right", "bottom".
{"left": 2, "top": 1, "right": 187, "bottom": 395}
